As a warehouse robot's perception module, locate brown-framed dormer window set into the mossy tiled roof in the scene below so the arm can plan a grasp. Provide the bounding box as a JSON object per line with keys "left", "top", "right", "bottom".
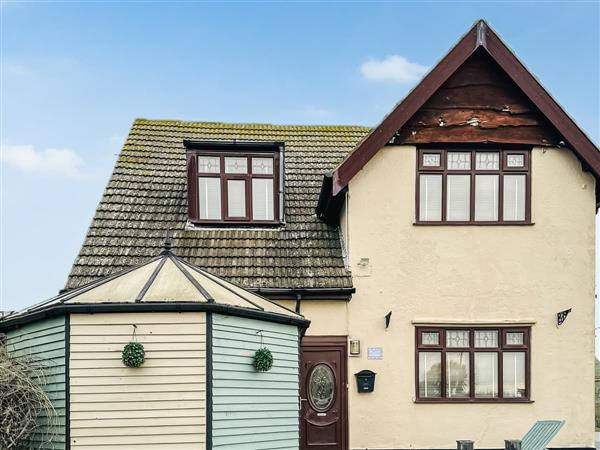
{"left": 184, "top": 141, "right": 283, "bottom": 225}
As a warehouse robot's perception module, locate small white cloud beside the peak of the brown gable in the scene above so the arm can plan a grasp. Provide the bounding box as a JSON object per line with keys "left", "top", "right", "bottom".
{"left": 360, "top": 55, "right": 429, "bottom": 84}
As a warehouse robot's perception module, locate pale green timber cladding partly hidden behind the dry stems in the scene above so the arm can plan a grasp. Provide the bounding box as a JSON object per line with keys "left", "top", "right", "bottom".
{"left": 7, "top": 316, "right": 66, "bottom": 450}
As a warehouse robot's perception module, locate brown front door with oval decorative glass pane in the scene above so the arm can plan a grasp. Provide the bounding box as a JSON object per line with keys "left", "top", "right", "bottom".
{"left": 300, "top": 336, "right": 348, "bottom": 450}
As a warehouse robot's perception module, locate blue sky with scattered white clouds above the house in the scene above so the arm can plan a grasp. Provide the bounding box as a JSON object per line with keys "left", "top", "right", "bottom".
{"left": 0, "top": 1, "right": 600, "bottom": 309}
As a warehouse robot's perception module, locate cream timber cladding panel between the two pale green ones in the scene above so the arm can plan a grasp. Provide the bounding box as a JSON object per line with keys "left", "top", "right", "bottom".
{"left": 70, "top": 312, "right": 206, "bottom": 450}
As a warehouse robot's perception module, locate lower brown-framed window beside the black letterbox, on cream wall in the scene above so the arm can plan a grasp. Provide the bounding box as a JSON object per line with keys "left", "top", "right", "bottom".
{"left": 415, "top": 327, "right": 531, "bottom": 402}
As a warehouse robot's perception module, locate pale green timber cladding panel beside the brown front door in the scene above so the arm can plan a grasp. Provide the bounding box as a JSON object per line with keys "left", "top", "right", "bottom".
{"left": 212, "top": 314, "right": 299, "bottom": 450}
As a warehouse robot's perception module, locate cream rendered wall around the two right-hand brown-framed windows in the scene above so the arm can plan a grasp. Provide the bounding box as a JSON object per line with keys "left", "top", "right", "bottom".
{"left": 338, "top": 146, "right": 595, "bottom": 449}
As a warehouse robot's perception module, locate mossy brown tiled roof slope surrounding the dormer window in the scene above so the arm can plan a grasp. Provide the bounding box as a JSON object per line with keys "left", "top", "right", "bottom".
{"left": 66, "top": 119, "right": 370, "bottom": 288}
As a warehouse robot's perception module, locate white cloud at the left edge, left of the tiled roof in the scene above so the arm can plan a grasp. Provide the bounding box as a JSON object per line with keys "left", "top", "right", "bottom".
{"left": 0, "top": 145, "right": 86, "bottom": 178}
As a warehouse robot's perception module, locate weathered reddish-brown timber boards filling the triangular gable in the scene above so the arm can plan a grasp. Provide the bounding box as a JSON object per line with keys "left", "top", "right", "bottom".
{"left": 393, "top": 51, "right": 561, "bottom": 146}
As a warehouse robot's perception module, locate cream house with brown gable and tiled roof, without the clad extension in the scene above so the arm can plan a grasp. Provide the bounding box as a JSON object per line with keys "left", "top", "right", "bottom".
{"left": 2, "top": 21, "right": 600, "bottom": 450}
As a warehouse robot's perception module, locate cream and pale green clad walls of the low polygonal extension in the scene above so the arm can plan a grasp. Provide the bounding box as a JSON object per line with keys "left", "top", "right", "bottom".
{"left": 8, "top": 312, "right": 299, "bottom": 450}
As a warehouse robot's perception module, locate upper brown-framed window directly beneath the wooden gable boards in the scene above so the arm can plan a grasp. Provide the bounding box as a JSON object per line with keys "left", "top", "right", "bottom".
{"left": 416, "top": 149, "right": 531, "bottom": 224}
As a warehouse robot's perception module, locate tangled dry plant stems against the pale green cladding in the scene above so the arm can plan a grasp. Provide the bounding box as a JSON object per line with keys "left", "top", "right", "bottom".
{"left": 0, "top": 345, "right": 58, "bottom": 450}
